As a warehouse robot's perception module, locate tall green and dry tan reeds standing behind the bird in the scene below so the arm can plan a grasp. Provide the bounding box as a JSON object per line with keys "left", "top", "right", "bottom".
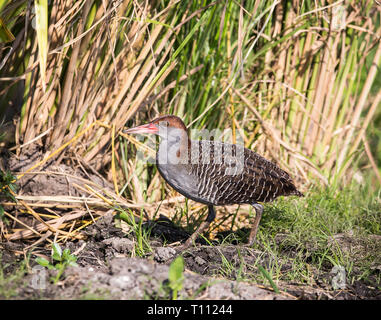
{"left": 0, "top": 0, "right": 381, "bottom": 201}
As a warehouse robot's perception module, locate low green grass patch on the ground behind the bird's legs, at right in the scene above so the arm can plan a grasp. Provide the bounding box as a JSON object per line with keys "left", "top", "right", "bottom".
{"left": 212, "top": 182, "right": 381, "bottom": 290}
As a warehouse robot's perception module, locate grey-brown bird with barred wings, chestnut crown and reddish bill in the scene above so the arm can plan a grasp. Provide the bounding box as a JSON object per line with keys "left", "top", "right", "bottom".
{"left": 123, "top": 115, "right": 303, "bottom": 249}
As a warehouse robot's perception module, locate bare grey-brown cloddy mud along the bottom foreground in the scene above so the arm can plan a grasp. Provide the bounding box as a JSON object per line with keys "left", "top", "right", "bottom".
{"left": 2, "top": 215, "right": 381, "bottom": 300}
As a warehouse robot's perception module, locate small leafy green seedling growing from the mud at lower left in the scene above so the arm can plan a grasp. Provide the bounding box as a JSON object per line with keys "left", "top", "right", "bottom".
{"left": 36, "top": 242, "right": 78, "bottom": 284}
